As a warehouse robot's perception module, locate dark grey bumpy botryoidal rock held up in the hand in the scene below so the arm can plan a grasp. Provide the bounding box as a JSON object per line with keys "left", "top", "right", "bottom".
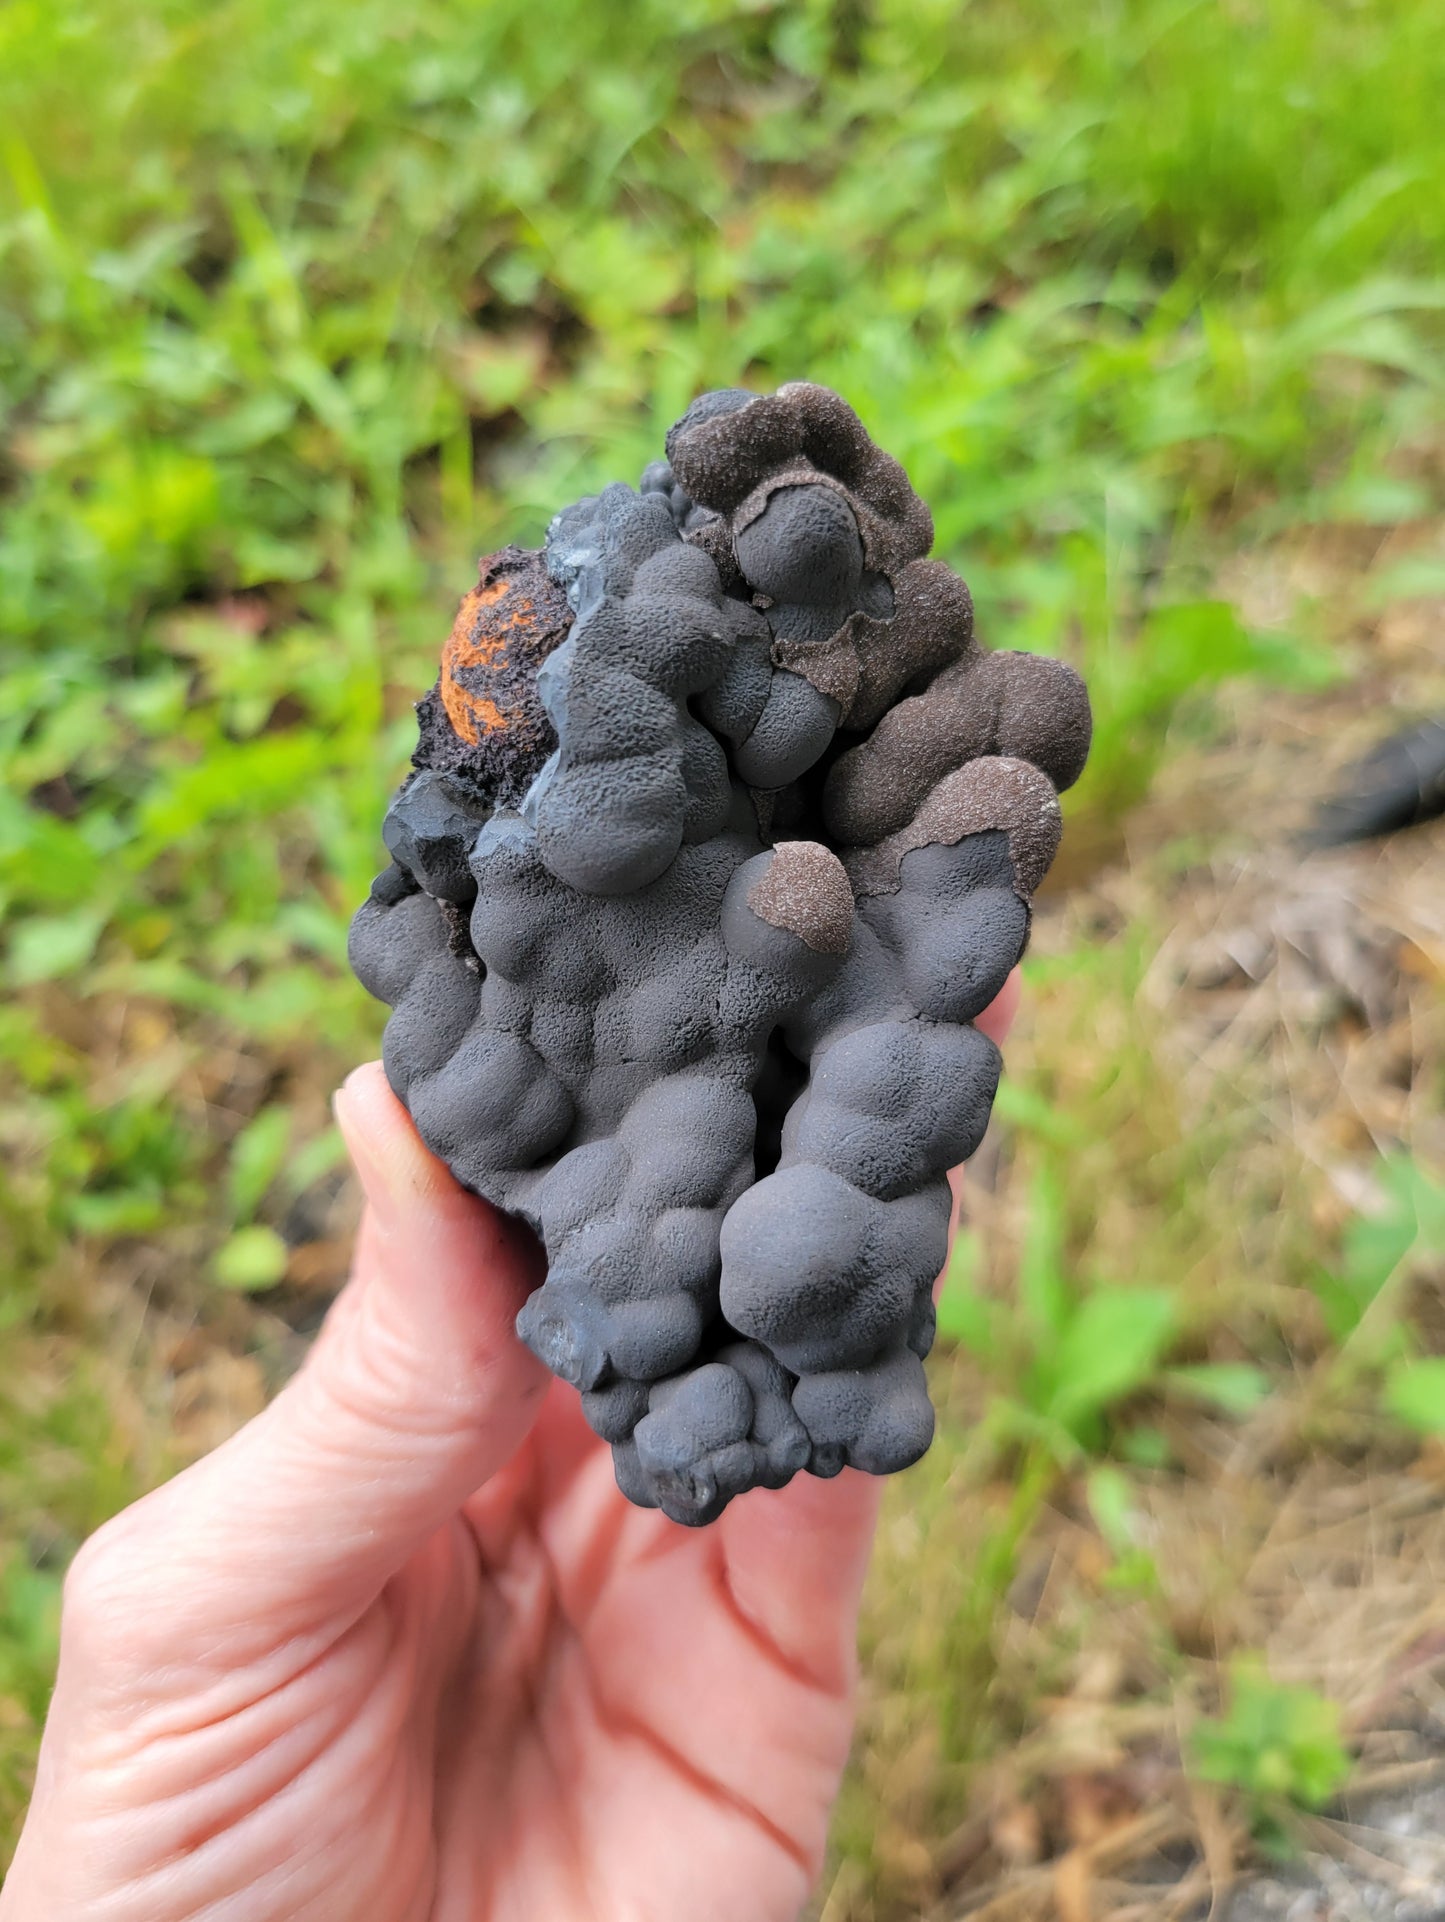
{"left": 352, "top": 382, "right": 1090, "bottom": 1524}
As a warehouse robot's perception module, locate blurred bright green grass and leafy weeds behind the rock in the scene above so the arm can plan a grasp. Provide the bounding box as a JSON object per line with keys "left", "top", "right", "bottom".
{"left": 0, "top": 0, "right": 1445, "bottom": 1898}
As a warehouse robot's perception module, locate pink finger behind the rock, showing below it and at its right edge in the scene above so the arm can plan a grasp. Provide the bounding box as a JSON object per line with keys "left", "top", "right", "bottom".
{"left": 717, "top": 969, "right": 1018, "bottom": 1686}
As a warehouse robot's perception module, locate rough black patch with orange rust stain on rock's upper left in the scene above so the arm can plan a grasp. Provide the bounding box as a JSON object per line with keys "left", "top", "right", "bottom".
{"left": 411, "top": 548, "right": 573, "bottom": 805}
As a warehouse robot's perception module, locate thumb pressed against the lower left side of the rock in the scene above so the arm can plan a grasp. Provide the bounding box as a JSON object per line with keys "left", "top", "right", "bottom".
{"left": 80, "top": 1063, "right": 548, "bottom": 1668}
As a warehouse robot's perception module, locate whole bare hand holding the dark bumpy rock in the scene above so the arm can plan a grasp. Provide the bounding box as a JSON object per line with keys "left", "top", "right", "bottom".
{"left": 0, "top": 984, "right": 1015, "bottom": 1922}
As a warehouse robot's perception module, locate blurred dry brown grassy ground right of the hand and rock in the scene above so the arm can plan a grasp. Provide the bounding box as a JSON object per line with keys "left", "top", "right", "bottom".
{"left": 820, "top": 534, "right": 1445, "bottom": 1922}
